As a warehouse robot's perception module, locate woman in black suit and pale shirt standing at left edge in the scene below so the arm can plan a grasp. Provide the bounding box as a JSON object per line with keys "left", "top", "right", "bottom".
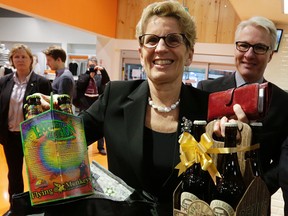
{"left": 0, "top": 44, "right": 52, "bottom": 216}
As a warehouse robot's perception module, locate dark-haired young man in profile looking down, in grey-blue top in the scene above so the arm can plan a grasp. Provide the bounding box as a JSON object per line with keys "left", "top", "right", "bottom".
{"left": 43, "top": 45, "right": 75, "bottom": 100}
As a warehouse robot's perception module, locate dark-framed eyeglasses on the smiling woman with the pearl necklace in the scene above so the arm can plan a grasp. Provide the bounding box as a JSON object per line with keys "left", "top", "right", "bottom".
{"left": 139, "top": 33, "right": 187, "bottom": 48}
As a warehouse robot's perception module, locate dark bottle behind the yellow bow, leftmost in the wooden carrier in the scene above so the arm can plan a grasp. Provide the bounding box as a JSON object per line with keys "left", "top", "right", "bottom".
{"left": 179, "top": 120, "right": 210, "bottom": 212}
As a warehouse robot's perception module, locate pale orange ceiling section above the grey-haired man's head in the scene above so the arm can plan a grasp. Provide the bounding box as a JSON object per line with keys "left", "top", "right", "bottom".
{"left": 229, "top": 0, "right": 288, "bottom": 25}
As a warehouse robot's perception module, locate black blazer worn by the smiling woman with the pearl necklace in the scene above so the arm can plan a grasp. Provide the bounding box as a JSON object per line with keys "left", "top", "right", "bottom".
{"left": 80, "top": 80, "right": 208, "bottom": 213}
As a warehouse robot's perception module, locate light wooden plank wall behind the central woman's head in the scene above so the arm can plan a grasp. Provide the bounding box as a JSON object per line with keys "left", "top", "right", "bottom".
{"left": 116, "top": 0, "right": 240, "bottom": 43}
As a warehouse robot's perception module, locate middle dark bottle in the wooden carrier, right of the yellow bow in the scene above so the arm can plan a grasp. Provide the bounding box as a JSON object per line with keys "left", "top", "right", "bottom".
{"left": 210, "top": 122, "right": 246, "bottom": 215}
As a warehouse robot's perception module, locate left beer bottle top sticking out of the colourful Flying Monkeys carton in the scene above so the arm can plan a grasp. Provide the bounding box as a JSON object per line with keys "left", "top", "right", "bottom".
{"left": 24, "top": 95, "right": 43, "bottom": 119}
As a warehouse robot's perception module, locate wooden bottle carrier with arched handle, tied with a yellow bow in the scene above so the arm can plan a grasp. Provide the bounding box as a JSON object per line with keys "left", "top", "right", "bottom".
{"left": 173, "top": 121, "right": 271, "bottom": 216}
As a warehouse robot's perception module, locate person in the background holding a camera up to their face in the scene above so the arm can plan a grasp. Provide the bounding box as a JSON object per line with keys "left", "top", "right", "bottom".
{"left": 73, "top": 57, "right": 110, "bottom": 155}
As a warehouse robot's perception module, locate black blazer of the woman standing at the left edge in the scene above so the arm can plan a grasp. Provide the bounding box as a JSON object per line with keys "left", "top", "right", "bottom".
{"left": 0, "top": 72, "right": 52, "bottom": 144}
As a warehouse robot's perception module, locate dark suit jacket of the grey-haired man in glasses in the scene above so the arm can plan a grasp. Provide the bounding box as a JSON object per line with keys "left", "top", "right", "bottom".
{"left": 197, "top": 73, "right": 288, "bottom": 194}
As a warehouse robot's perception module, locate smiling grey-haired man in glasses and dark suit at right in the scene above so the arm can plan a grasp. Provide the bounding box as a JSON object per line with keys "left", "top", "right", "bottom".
{"left": 197, "top": 17, "right": 288, "bottom": 213}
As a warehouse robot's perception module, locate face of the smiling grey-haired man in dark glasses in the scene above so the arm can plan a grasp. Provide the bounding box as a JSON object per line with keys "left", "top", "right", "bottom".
{"left": 235, "top": 26, "right": 273, "bottom": 82}
